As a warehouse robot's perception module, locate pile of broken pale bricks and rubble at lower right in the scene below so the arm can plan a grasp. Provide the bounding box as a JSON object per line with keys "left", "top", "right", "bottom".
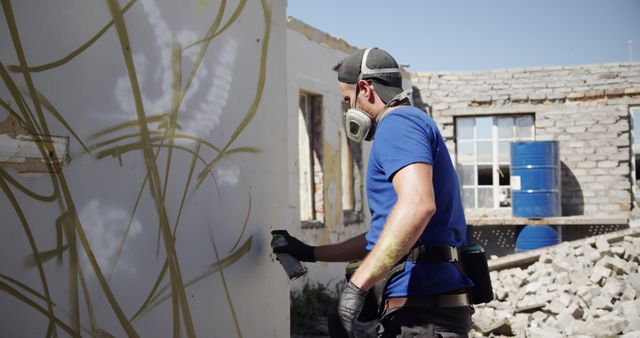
{"left": 470, "top": 236, "right": 640, "bottom": 338}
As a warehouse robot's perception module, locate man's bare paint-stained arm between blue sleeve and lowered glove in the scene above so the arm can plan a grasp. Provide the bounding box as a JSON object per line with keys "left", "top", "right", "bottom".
{"left": 351, "top": 163, "right": 436, "bottom": 290}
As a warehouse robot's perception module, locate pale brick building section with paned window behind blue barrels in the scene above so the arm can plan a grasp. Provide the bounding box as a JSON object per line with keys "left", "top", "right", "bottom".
{"left": 413, "top": 58, "right": 640, "bottom": 253}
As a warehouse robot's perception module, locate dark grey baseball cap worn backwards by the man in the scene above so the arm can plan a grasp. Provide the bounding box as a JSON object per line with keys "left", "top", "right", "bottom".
{"left": 334, "top": 48, "right": 402, "bottom": 103}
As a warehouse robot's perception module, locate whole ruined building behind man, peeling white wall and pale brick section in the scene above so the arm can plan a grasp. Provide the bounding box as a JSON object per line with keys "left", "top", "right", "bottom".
{"left": 287, "top": 17, "right": 640, "bottom": 283}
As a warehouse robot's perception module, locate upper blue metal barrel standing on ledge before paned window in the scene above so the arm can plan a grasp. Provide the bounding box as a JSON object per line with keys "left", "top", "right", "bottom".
{"left": 511, "top": 141, "right": 562, "bottom": 218}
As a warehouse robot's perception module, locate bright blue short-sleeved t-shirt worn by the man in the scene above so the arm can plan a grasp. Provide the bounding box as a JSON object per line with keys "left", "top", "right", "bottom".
{"left": 366, "top": 106, "right": 473, "bottom": 297}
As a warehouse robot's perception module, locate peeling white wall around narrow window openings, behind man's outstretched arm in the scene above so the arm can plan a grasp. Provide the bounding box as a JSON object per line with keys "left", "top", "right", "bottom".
{"left": 287, "top": 24, "right": 369, "bottom": 289}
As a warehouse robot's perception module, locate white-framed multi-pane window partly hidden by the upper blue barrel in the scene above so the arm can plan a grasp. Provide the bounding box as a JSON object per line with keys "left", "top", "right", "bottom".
{"left": 455, "top": 115, "right": 534, "bottom": 209}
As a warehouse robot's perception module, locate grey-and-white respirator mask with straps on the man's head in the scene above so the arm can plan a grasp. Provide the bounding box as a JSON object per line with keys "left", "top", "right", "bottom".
{"left": 345, "top": 48, "right": 411, "bottom": 142}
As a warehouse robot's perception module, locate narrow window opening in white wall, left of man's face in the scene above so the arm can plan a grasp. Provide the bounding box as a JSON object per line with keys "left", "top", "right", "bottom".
{"left": 298, "top": 92, "right": 324, "bottom": 227}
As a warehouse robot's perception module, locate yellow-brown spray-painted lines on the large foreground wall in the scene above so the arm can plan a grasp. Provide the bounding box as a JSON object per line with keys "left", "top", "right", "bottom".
{"left": 0, "top": 0, "right": 271, "bottom": 337}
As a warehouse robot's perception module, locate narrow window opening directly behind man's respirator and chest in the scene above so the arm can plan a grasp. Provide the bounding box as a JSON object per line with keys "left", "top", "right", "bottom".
{"left": 341, "top": 102, "right": 363, "bottom": 225}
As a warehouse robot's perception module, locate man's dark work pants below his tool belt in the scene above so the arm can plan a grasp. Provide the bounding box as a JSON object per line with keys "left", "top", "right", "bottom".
{"left": 327, "top": 306, "right": 473, "bottom": 338}
